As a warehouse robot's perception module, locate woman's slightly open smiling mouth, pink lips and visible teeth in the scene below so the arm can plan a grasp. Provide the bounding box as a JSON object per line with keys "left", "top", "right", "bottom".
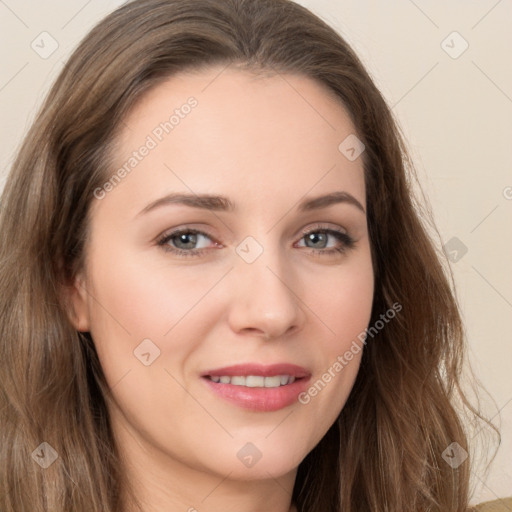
{"left": 201, "top": 364, "right": 311, "bottom": 412}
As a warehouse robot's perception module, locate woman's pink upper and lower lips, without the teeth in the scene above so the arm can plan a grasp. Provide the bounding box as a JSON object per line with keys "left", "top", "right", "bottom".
{"left": 201, "top": 363, "right": 311, "bottom": 412}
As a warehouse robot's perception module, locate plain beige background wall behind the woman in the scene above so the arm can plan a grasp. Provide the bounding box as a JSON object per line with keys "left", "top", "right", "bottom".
{"left": 0, "top": 0, "right": 512, "bottom": 503}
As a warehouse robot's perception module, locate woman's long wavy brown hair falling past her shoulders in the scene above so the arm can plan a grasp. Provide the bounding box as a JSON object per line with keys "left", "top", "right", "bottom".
{"left": 0, "top": 0, "right": 498, "bottom": 512}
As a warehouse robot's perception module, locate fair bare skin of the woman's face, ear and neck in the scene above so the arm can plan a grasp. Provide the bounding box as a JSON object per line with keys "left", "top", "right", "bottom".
{"left": 67, "top": 67, "right": 374, "bottom": 512}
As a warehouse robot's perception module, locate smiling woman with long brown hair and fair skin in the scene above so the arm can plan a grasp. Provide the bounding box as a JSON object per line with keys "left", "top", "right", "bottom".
{"left": 0, "top": 0, "right": 502, "bottom": 512}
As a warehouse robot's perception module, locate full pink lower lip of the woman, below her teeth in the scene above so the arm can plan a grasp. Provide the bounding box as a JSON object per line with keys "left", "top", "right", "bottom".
{"left": 202, "top": 377, "right": 309, "bottom": 412}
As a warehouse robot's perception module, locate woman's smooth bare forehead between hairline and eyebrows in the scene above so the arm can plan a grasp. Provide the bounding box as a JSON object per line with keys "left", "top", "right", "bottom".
{"left": 99, "top": 66, "right": 364, "bottom": 217}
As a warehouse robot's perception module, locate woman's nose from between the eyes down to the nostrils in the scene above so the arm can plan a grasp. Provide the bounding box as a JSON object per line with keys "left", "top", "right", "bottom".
{"left": 228, "top": 245, "right": 305, "bottom": 341}
